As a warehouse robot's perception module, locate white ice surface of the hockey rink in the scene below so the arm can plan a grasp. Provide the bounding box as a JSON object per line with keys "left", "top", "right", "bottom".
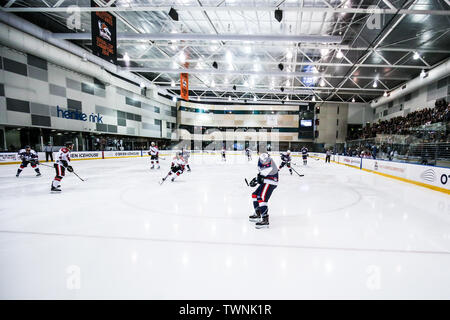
{"left": 0, "top": 155, "right": 450, "bottom": 300}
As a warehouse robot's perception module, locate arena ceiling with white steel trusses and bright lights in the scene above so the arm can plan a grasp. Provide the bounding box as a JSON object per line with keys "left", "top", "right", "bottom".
{"left": 1, "top": 0, "right": 450, "bottom": 102}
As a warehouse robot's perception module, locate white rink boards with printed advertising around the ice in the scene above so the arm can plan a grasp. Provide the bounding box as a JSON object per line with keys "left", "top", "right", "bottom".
{"left": 0, "top": 150, "right": 450, "bottom": 194}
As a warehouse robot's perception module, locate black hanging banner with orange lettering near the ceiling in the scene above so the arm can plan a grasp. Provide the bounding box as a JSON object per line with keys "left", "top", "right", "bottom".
{"left": 91, "top": 0, "right": 117, "bottom": 64}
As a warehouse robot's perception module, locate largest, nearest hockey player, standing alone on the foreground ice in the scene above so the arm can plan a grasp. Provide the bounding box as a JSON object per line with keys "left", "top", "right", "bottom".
{"left": 249, "top": 153, "right": 278, "bottom": 229}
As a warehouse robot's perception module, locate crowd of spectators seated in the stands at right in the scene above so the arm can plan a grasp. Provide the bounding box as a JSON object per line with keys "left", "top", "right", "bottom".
{"left": 349, "top": 100, "right": 450, "bottom": 140}
